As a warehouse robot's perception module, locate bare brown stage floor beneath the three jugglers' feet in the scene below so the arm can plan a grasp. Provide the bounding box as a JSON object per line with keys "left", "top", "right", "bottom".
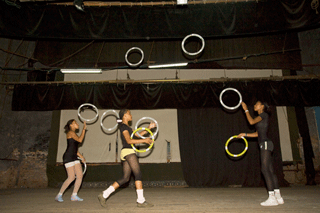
{"left": 0, "top": 185, "right": 320, "bottom": 213}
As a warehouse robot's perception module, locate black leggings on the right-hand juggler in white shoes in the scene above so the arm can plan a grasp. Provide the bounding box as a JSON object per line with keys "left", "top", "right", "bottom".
{"left": 260, "top": 150, "right": 279, "bottom": 191}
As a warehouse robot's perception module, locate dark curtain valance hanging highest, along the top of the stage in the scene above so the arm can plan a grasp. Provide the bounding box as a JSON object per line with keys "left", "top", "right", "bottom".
{"left": 0, "top": 0, "right": 320, "bottom": 40}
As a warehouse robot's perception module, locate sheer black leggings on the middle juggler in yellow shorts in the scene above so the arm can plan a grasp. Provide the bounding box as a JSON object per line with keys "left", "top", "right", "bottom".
{"left": 117, "top": 154, "right": 142, "bottom": 186}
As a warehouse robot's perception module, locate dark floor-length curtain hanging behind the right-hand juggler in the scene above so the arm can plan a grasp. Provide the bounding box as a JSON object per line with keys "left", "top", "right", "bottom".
{"left": 178, "top": 107, "right": 287, "bottom": 187}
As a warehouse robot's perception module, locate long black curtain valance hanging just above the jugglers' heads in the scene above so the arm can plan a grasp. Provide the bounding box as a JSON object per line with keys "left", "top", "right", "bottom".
{"left": 12, "top": 78, "right": 320, "bottom": 111}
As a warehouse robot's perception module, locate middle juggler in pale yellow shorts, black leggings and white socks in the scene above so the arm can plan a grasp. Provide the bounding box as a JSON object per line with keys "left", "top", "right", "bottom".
{"left": 98, "top": 109, "right": 156, "bottom": 207}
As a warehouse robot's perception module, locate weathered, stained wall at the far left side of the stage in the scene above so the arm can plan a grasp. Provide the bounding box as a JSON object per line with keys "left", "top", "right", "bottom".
{"left": 0, "top": 38, "right": 52, "bottom": 189}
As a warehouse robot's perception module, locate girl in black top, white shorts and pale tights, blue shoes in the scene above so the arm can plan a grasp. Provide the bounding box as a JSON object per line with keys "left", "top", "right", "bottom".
{"left": 55, "top": 119, "right": 87, "bottom": 202}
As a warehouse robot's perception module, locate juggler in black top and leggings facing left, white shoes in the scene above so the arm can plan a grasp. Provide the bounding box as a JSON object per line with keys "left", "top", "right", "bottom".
{"left": 238, "top": 101, "right": 284, "bottom": 206}
